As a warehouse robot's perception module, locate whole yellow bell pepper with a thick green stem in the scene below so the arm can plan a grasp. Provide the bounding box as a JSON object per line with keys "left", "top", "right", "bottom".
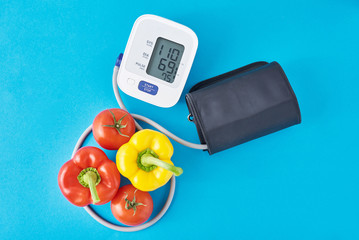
{"left": 116, "top": 129, "right": 183, "bottom": 191}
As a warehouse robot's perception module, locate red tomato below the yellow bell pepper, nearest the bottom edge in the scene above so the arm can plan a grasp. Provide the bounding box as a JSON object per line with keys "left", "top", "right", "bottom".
{"left": 111, "top": 184, "right": 153, "bottom": 226}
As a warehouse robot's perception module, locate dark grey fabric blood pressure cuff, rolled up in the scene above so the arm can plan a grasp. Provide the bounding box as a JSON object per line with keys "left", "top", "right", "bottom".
{"left": 186, "top": 62, "right": 301, "bottom": 154}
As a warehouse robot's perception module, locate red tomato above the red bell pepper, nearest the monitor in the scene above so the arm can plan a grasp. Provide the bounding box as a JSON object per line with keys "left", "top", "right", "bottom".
{"left": 92, "top": 108, "right": 136, "bottom": 150}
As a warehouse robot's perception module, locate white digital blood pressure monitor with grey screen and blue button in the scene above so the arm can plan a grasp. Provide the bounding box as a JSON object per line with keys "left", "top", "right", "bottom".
{"left": 117, "top": 14, "right": 198, "bottom": 107}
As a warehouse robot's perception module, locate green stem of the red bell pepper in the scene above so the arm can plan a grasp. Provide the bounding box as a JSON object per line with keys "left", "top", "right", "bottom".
{"left": 77, "top": 167, "right": 101, "bottom": 203}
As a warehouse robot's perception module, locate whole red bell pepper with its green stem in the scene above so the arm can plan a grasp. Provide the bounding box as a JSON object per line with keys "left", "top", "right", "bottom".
{"left": 58, "top": 147, "right": 120, "bottom": 207}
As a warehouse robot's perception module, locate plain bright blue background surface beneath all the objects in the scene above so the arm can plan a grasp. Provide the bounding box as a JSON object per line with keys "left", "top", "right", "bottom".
{"left": 0, "top": 0, "right": 359, "bottom": 239}
